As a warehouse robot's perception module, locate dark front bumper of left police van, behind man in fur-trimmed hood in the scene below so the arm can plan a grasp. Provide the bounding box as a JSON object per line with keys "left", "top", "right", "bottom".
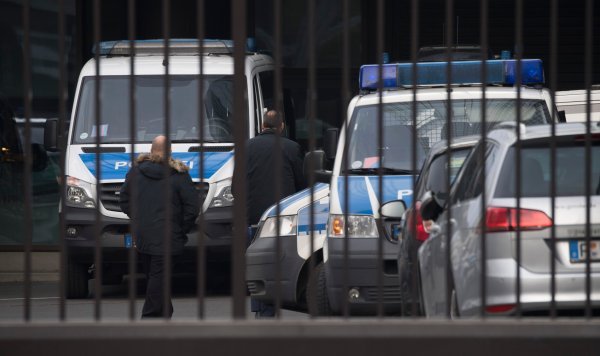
{"left": 64, "top": 207, "right": 233, "bottom": 262}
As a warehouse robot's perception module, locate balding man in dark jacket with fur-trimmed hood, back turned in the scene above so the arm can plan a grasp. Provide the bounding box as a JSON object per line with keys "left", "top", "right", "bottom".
{"left": 120, "top": 136, "right": 199, "bottom": 318}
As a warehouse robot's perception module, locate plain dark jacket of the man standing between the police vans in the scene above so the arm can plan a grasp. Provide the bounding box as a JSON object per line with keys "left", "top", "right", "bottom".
{"left": 233, "top": 130, "right": 306, "bottom": 225}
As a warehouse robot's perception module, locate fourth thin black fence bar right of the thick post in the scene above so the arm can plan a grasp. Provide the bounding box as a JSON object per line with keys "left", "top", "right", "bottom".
{"left": 373, "top": 0, "right": 384, "bottom": 317}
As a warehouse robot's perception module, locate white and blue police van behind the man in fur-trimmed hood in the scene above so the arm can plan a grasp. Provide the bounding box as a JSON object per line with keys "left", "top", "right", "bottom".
{"left": 54, "top": 39, "right": 274, "bottom": 297}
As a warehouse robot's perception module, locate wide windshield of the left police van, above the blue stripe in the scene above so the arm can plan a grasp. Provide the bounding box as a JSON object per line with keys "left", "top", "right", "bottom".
{"left": 73, "top": 75, "right": 239, "bottom": 144}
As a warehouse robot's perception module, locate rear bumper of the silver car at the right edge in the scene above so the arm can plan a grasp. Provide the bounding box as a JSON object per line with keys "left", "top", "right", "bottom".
{"left": 457, "top": 259, "right": 600, "bottom": 316}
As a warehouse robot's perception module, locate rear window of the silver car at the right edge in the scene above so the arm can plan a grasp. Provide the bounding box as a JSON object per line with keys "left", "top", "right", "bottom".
{"left": 495, "top": 142, "right": 600, "bottom": 198}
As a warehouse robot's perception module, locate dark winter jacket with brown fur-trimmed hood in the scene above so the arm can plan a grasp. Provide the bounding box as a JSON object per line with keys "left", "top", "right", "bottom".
{"left": 120, "top": 154, "right": 199, "bottom": 255}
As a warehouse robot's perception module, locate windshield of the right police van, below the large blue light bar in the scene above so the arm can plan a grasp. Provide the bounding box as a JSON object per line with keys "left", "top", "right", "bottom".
{"left": 345, "top": 99, "right": 551, "bottom": 173}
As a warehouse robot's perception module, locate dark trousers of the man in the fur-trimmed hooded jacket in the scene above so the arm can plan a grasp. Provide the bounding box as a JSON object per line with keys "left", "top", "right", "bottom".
{"left": 139, "top": 253, "right": 173, "bottom": 319}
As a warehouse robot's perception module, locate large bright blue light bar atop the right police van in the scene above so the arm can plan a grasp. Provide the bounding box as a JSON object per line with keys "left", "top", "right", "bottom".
{"left": 359, "top": 59, "right": 544, "bottom": 90}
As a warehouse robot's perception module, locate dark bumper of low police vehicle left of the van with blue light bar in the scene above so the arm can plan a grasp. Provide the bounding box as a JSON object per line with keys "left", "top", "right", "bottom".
{"left": 246, "top": 236, "right": 306, "bottom": 309}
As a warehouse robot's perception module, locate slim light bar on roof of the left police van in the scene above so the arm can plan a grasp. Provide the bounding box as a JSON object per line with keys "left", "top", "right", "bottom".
{"left": 92, "top": 38, "right": 233, "bottom": 56}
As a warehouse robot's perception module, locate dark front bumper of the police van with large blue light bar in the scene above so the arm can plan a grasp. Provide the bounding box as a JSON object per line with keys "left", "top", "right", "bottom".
{"left": 325, "top": 238, "right": 401, "bottom": 314}
